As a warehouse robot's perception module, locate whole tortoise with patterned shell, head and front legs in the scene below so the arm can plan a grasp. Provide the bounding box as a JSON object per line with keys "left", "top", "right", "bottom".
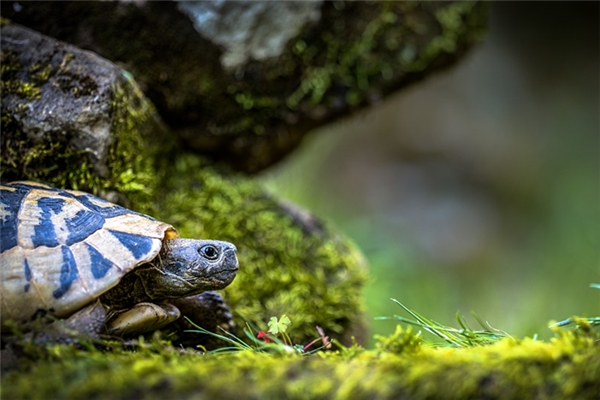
{"left": 0, "top": 181, "right": 238, "bottom": 337}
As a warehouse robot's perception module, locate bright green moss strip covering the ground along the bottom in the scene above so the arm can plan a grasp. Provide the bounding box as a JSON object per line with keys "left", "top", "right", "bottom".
{"left": 1, "top": 324, "right": 600, "bottom": 400}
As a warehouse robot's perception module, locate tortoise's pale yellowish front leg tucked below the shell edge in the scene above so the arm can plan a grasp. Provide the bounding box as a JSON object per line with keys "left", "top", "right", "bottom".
{"left": 106, "top": 303, "right": 180, "bottom": 336}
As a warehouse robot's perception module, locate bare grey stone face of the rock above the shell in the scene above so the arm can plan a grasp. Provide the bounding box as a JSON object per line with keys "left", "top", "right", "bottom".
{"left": 1, "top": 24, "right": 115, "bottom": 177}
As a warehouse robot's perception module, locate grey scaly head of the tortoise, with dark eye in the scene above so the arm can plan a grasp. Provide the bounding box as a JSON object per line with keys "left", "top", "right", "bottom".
{"left": 136, "top": 238, "right": 238, "bottom": 299}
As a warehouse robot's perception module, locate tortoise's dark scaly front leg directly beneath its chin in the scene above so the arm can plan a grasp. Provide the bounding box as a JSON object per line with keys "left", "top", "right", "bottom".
{"left": 169, "top": 291, "right": 236, "bottom": 349}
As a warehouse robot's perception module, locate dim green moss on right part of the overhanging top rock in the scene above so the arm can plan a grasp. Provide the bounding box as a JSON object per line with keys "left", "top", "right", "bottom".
{"left": 280, "top": 2, "right": 485, "bottom": 109}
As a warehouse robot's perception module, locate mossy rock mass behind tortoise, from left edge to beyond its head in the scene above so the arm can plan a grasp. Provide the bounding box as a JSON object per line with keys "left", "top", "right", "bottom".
{"left": 1, "top": 24, "right": 366, "bottom": 341}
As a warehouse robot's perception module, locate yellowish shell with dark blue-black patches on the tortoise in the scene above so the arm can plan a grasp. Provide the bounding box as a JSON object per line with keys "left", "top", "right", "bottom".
{"left": 0, "top": 182, "right": 178, "bottom": 325}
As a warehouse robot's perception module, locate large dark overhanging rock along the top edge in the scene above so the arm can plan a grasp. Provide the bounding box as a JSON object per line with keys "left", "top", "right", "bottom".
{"left": 1, "top": 1, "right": 486, "bottom": 173}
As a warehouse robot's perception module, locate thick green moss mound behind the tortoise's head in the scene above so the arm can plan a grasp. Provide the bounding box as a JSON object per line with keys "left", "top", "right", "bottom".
{"left": 155, "top": 155, "right": 365, "bottom": 343}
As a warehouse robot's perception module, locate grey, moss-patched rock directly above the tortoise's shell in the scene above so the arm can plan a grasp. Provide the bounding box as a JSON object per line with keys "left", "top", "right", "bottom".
{"left": 1, "top": 23, "right": 171, "bottom": 209}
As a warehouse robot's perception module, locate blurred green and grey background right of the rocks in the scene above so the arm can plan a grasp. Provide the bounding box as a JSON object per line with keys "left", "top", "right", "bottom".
{"left": 261, "top": 2, "right": 600, "bottom": 344}
